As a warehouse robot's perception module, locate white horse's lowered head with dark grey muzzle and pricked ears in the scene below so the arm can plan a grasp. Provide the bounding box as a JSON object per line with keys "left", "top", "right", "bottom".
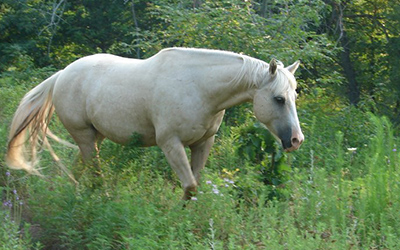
{"left": 253, "top": 59, "right": 304, "bottom": 152}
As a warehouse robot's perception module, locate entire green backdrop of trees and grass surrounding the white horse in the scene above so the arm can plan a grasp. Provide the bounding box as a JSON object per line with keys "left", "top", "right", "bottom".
{"left": 0, "top": 0, "right": 400, "bottom": 249}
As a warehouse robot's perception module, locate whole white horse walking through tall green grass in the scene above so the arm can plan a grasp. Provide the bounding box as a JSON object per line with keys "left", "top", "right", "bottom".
{"left": 6, "top": 48, "right": 304, "bottom": 200}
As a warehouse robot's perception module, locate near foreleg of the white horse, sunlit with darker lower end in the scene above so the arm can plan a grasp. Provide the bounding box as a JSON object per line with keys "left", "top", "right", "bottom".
{"left": 159, "top": 138, "right": 197, "bottom": 200}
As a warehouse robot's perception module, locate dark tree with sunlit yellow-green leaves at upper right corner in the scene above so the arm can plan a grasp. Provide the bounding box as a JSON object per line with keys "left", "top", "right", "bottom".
{"left": 320, "top": 0, "right": 400, "bottom": 111}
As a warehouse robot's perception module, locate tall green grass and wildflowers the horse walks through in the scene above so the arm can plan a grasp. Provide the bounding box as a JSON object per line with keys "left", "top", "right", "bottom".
{"left": 0, "top": 70, "right": 400, "bottom": 249}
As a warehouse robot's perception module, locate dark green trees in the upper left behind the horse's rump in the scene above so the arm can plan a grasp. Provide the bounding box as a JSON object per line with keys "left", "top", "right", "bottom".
{"left": 0, "top": 0, "right": 152, "bottom": 69}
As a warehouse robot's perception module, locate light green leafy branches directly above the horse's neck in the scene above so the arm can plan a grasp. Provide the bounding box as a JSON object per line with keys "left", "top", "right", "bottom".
{"left": 150, "top": 0, "right": 334, "bottom": 74}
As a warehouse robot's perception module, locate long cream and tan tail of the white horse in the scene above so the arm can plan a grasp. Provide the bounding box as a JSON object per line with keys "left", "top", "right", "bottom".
{"left": 6, "top": 71, "right": 61, "bottom": 175}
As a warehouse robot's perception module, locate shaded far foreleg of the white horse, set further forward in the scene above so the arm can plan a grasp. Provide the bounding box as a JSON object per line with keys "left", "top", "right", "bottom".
{"left": 190, "top": 136, "right": 215, "bottom": 183}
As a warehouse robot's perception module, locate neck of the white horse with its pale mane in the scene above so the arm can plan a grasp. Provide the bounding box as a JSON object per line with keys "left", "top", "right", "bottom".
{"left": 154, "top": 48, "right": 262, "bottom": 112}
